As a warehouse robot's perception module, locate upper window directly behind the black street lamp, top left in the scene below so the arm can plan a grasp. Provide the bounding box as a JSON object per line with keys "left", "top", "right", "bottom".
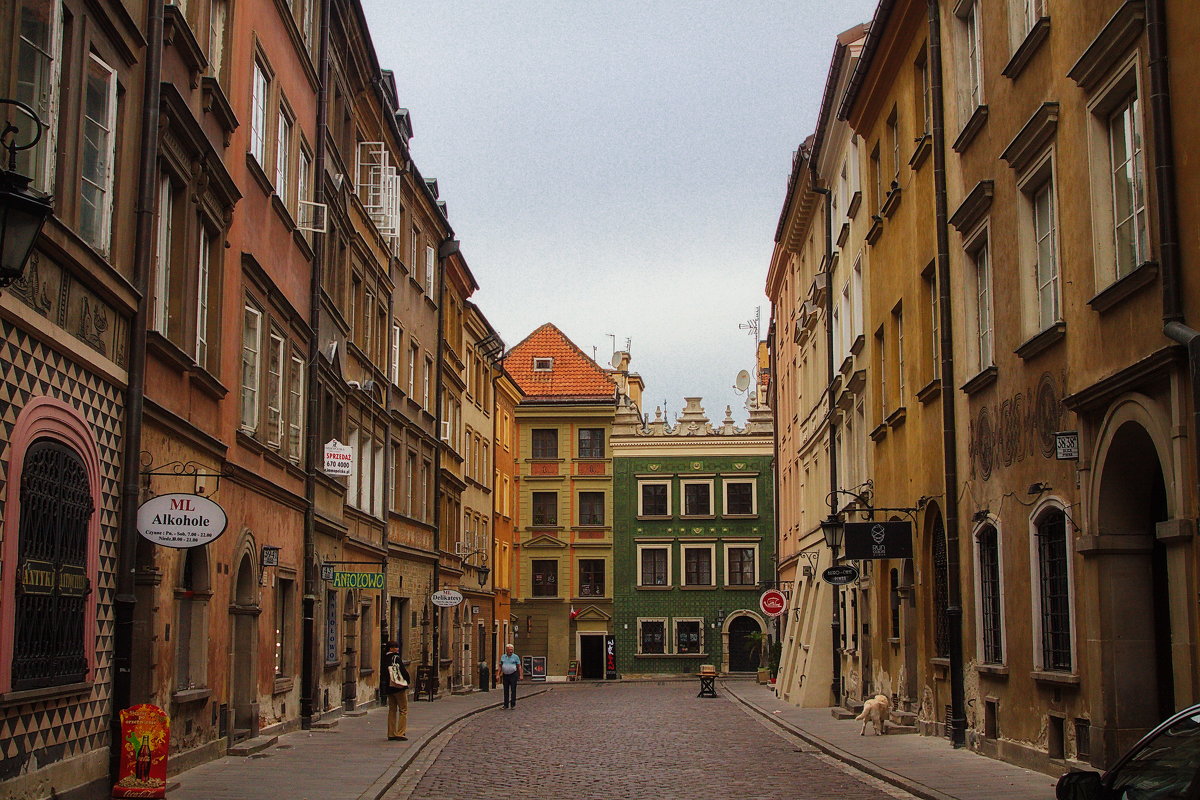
{"left": 14, "top": 0, "right": 62, "bottom": 192}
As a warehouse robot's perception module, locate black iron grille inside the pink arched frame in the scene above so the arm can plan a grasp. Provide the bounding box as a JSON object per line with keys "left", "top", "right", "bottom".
{"left": 12, "top": 439, "right": 94, "bottom": 690}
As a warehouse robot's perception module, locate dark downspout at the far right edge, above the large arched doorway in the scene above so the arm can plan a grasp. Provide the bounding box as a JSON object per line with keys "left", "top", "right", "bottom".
{"left": 1146, "top": 0, "right": 1200, "bottom": 510}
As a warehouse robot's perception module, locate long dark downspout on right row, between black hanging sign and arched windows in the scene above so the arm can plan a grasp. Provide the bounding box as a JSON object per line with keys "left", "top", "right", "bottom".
{"left": 929, "top": 0, "right": 967, "bottom": 747}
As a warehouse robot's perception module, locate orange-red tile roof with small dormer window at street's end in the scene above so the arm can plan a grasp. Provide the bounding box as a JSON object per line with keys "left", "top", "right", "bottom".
{"left": 504, "top": 323, "right": 617, "bottom": 399}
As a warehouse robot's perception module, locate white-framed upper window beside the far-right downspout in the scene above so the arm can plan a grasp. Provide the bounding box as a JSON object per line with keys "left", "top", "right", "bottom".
{"left": 1108, "top": 95, "right": 1150, "bottom": 278}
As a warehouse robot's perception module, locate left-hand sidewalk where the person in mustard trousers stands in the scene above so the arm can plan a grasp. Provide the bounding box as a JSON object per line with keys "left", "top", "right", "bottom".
{"left": 167, "top": 684, "right": 550, "bottom": 800}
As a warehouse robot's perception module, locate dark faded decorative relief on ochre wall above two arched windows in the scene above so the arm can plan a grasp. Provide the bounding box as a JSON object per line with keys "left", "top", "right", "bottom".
{"left": 968, "top": 372, "right": 1067, "bottom": 481}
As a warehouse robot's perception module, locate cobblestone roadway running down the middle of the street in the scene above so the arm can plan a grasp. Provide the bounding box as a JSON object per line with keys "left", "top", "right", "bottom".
{"left": 385, "top": 682, "right": 912, "bottom": 800}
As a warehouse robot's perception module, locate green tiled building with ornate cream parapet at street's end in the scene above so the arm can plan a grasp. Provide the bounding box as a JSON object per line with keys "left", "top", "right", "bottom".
{"left": 611, "top": 397, "right": 775, "bottom": 676}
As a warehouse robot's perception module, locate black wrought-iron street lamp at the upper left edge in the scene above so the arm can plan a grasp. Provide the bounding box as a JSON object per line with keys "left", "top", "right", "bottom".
{"left": 0, "top": 97, "right": 54, "bottom": 287}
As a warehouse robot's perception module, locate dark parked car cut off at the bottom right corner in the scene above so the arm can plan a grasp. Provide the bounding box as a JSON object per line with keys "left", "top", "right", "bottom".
{"left": 1055, "top": 704, "right": 1200, "bottom": 800}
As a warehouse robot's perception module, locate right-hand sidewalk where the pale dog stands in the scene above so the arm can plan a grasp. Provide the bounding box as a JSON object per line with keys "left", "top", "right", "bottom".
{"left": 719, "top": 681, "right": 1055, "bottom": 800}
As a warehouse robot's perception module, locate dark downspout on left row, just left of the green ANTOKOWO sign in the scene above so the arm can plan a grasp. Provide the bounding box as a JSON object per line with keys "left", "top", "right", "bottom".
{"left": 300, "top": 0, "right": 331, "bottom": 730}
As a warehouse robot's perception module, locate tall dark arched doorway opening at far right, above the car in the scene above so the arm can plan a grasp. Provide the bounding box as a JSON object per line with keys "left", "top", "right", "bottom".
{"left": 1092, "top": 420, "right": 1175, "bottom": 760}
